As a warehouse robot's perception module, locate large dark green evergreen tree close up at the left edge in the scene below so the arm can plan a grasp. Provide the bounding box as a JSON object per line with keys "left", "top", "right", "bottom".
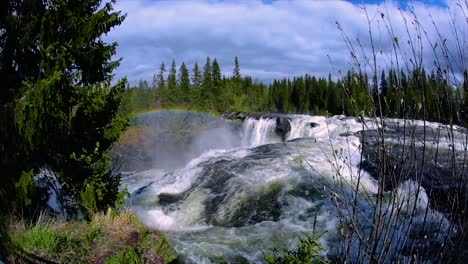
{"left": 0, "top": 0, "right": 128, "bottom": 214}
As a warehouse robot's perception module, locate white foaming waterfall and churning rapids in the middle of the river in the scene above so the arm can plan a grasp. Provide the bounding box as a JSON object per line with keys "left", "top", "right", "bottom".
{"left": 122, "top": 112, "right": 466, "bottom": 263}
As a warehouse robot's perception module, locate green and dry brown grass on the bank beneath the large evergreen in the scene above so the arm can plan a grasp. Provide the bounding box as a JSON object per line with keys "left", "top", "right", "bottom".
{"left": 8, "top": 211, "right": 176, "bottom": 263}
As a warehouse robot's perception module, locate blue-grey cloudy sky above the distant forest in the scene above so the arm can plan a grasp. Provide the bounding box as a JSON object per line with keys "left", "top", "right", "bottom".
{"left": 106, "top": 0, "right": 468, "bottom": 84}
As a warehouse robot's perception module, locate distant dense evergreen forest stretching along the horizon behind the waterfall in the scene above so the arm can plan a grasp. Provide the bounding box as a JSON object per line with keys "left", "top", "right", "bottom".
{"left": 124, "top": 57, "right": 464, "bottom": 124}
